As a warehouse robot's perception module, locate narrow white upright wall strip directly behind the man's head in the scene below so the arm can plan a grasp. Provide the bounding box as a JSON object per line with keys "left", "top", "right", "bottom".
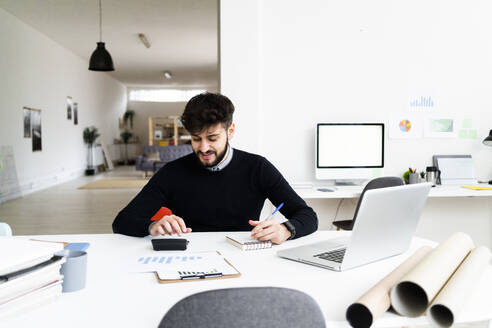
{"left": 220, "top": 0, "right": 264, "bottom": 153}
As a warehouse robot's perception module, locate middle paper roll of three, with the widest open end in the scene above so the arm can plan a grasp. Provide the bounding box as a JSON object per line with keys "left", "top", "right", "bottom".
{"left": 390, "top": 232, "right": 474, "bottom": 317}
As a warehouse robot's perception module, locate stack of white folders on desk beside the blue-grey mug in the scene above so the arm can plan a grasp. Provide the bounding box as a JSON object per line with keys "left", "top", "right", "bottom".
{"left": 0, "top": 237, "right": 65, "bottom": 318}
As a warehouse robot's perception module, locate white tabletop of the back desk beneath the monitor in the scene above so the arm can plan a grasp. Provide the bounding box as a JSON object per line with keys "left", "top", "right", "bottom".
{"left": 294, "top": 184, "right": 492, "bottom": 199}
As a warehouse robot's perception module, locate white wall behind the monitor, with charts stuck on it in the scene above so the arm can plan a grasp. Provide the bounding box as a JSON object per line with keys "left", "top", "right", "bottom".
{"left": 221, "top": 0, "right": 492, "bottom": 182}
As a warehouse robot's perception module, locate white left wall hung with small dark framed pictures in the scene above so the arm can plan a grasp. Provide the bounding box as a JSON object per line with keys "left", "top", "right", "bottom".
{"left": 0, "top": 9, "right": 126, "bottom": 201}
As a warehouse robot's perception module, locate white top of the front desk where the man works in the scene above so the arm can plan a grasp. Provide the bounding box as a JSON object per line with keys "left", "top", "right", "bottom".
{"left": 0, "top": 231, "right": 492, "bottom": 328}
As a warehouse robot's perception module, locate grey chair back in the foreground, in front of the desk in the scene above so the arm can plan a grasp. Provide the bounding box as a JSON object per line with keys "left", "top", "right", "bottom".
{"left": 159, "top": 287, "right": 325, "bottom": 328}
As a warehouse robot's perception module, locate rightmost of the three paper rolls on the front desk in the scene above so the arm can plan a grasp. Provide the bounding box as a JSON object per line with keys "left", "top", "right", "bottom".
{"left": 427, "top": 246, "right": 490, "bottom": 327}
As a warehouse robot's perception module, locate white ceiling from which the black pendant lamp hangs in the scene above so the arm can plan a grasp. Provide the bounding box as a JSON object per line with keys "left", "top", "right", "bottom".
{"left": 0, "top": 0, "right": 219, "bottom": 89}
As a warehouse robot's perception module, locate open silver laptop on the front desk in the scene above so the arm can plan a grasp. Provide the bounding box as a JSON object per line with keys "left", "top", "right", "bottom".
{"left": 277, "top": 183, "right": 431, "bottom": 271}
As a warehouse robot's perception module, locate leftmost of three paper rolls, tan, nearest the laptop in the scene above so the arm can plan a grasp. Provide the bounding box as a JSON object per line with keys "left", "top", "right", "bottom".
{"left": 345, "top": 246, "right": 432, "bottom": 328}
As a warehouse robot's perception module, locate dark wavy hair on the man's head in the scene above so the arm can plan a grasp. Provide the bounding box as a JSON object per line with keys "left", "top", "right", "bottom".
{"left": 181, "top": 92, "right": 234, "bottom": 133}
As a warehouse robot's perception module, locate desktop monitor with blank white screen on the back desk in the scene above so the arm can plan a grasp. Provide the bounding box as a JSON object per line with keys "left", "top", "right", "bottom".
{"left": 315, "top": 123, "right": 384, "bottom": 183}
